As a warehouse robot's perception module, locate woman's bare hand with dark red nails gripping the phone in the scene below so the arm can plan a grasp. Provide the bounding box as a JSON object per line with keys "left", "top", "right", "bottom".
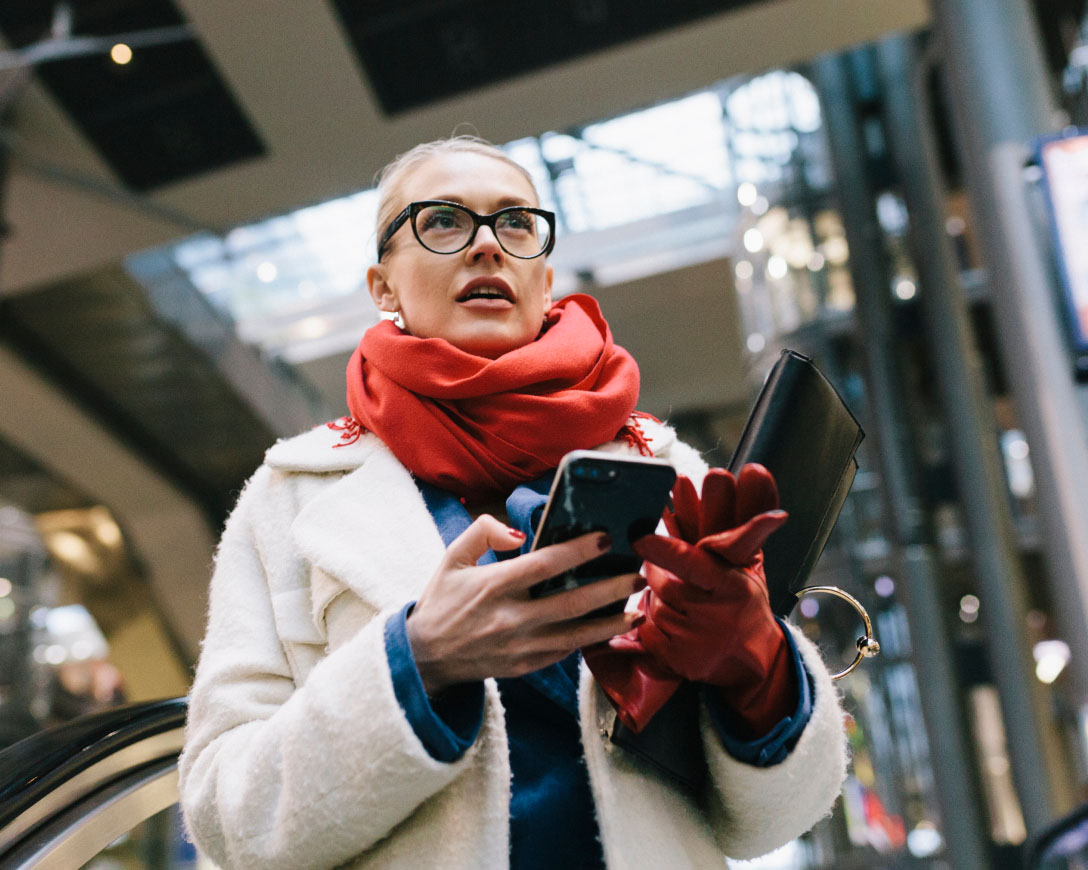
{"left": 408, "top": 514, "right": 645, "bottom": 694}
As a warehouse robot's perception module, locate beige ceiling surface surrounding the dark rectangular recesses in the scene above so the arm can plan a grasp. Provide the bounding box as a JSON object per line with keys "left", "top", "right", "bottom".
{"left": 0, "top": 0, "right": 929, "bottom": 295}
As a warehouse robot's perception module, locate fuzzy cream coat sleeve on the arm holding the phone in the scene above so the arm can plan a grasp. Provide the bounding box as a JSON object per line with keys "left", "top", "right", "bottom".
{"left": 178, "top": 469, "right": 478, "bottom": 870}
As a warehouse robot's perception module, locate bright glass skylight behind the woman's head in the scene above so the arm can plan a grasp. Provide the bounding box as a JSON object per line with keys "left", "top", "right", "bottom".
{"left": 158, "top": 71, "right": 820, "bottom": 361}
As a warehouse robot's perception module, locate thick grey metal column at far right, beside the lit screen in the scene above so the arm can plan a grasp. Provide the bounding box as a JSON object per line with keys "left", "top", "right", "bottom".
{"left": 932, "top": 0, "right": 1088, "bottom": 804}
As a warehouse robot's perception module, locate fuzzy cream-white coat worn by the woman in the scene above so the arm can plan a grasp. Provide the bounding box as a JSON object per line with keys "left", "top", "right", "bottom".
{"left": 180, "top": 421, "right": 846, "bottom": 870}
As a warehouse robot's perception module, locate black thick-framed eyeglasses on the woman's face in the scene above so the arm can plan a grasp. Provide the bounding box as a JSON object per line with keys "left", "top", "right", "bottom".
{"left": 378, "top": 199, "right": 555, "bottom": 260}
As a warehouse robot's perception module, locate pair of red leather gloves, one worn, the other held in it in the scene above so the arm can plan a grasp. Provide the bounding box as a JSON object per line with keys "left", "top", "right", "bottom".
{"left": 583, "top": 464, "right": 796, "bottom": 737}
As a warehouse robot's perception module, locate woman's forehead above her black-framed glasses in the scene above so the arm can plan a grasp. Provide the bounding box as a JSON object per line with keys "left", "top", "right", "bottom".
{"left": 397, "top": 151, "right": 536, "bottom": 211}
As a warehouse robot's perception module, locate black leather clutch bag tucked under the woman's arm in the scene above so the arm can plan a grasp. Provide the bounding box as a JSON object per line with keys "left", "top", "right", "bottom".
{"left": 611, "top": 350, "right": 865, "bottom": 790}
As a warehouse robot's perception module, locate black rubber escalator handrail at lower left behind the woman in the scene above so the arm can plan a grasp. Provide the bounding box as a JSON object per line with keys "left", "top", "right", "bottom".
{"left": 0, "top": 698, "right": 188, "bottom": 830}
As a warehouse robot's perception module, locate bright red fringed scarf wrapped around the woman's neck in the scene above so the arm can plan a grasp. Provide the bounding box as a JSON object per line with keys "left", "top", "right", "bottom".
{"left": 339, "top": 294, "right": 644, "bottom": 502}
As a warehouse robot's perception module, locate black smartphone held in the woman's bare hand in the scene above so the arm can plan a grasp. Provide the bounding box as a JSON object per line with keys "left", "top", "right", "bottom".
{"left": 529, "top": 450, "right": 677, "bottom": 616}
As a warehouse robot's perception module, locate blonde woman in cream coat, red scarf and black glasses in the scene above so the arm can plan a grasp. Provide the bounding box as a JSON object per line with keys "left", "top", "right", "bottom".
{"left": 180, "top": 138, "right": 845, "bottom": 870}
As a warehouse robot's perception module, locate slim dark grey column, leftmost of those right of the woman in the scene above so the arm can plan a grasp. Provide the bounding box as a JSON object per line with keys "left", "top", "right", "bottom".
{"left": 813, "top": 51, "right": 990, "bottom": 870}
